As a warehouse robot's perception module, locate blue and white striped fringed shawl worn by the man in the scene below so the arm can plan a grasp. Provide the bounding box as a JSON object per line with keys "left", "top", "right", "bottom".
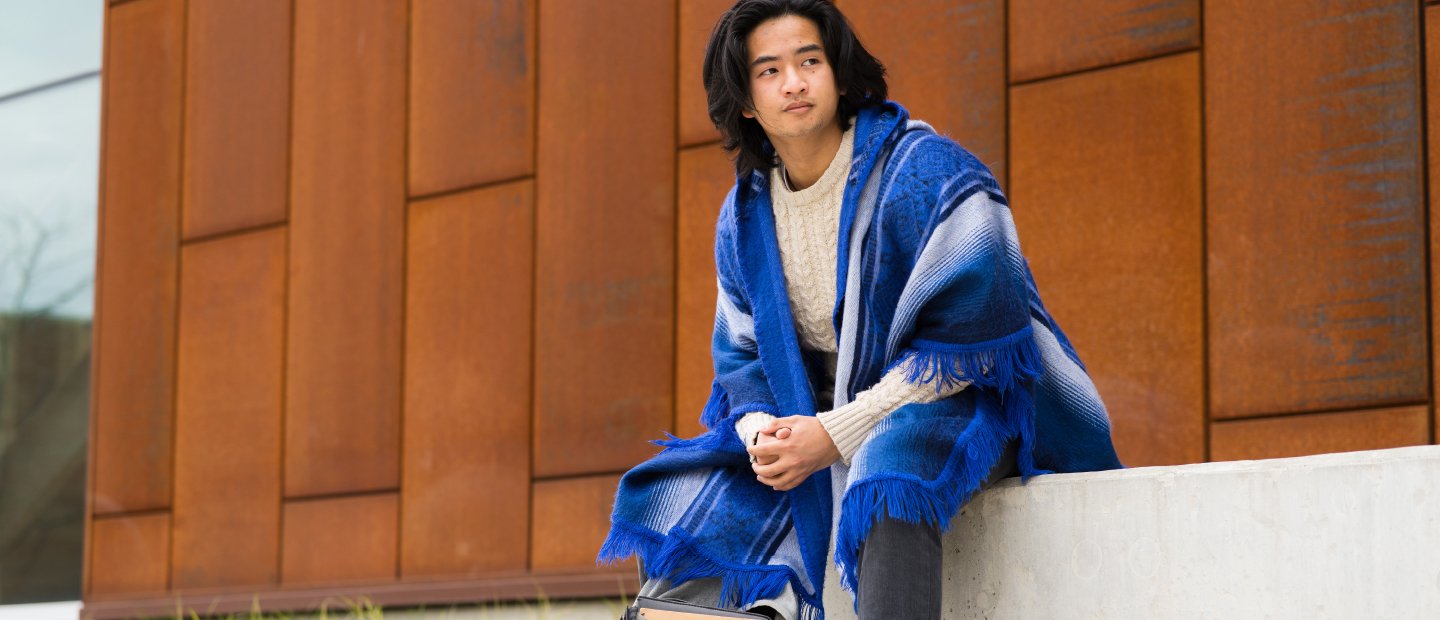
{"left": 600, "top": 102, "right": 1120, "bottom": 619}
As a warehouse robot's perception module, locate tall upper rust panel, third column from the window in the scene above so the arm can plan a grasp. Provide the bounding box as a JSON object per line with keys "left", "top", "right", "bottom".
{"left": 285, "top": 0, "right": 406, "bottom": 496}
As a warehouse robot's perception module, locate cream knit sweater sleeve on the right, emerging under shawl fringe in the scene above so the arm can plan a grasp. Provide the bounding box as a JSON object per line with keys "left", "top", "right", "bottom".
{"left": 815, "top": 364, "right": 971, "bottom": 465}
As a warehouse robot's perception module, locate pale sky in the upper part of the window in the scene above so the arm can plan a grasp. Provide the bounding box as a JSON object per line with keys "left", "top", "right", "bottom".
{"left": 0, "top": 0, "right": 104, "bottom": 318}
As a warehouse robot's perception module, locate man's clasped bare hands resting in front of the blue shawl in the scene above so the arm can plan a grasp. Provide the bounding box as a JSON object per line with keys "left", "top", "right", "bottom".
{"left": 749, "top": 416, "right": 840, "bottom": 491}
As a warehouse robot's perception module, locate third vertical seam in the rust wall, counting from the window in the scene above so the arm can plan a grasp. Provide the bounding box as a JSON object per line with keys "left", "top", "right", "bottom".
{"left": 395, "top": 0, "right": 415, "bottom": 580}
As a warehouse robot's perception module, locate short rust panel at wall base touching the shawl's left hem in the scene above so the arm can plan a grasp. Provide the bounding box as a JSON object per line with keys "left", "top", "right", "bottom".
{"left": 530, "top": 476, "right": 635, "bottom": 571}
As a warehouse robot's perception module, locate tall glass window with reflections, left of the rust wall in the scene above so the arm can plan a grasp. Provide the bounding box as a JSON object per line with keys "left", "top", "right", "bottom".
{"left": 0, "top": 0, "right": 104, "bottom": 604}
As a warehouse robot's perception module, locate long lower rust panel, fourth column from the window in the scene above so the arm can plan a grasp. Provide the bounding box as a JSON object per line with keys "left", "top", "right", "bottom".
{"left": 400, "top": 181, "right": 534, "bottom": 575}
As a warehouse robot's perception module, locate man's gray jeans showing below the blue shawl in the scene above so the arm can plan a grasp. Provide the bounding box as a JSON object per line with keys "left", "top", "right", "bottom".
{"left": 639, "top": 442, "right": 1020, "bottom": 620}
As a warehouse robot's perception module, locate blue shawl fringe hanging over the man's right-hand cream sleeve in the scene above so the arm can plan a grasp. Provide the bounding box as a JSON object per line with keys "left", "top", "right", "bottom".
{"left": 891, "top": 325, "right": 1044, "bottom": 394}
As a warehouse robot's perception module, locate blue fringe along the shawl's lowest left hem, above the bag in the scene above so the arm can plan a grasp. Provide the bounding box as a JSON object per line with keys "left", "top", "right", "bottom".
{"left": 598, "top": 522, "right": 825, "bottom": 620}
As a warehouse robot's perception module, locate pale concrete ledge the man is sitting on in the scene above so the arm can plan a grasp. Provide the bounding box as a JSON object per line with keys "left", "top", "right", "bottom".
{"left": 933, "top": 446, "right": 1440, "bottom": 619}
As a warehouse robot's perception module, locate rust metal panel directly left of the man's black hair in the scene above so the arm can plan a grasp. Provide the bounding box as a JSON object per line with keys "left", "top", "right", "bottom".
{"left": 677, "top": 0, "right": 734, "bottom": 147}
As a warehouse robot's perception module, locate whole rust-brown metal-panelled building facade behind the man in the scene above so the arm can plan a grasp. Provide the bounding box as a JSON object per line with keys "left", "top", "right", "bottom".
{"left": 85, "top": 0, "right": 1440, "bottom": 617}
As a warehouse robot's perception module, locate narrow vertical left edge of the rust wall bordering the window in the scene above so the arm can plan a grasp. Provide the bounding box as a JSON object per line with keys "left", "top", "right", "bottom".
{"left": 81, "top": 4, "right": 114, "bottom": 600}
